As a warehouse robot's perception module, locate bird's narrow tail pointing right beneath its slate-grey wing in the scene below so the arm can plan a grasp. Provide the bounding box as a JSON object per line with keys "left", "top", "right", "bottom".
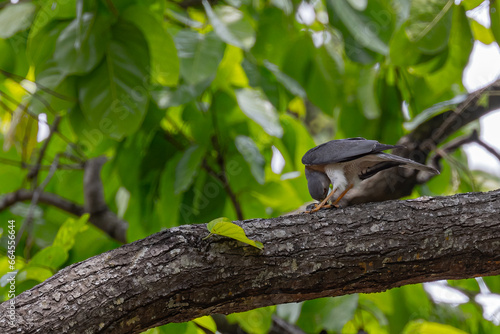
{"left": 356, "top": 153, "right": 439, "bottom": 180}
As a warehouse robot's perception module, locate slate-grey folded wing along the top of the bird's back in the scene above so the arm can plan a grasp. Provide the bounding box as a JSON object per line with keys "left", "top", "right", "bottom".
{"left": 302, "top": 138, "right": 399, "bottom": 165}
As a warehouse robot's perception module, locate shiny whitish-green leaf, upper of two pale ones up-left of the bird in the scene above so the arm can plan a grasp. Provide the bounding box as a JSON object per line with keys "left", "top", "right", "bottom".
{"left": 236, "top": 88, "right": 283, "bottom": 138}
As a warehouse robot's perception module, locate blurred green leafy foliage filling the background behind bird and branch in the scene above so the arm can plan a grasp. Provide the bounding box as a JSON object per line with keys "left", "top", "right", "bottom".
{"left": 0, "top": 0, "right": 500, "bottom": 333}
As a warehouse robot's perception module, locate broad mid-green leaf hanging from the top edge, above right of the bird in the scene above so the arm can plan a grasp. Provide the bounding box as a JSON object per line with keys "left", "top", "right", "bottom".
{"left": 406, "top": 0, "right": 453, "bottom": 54}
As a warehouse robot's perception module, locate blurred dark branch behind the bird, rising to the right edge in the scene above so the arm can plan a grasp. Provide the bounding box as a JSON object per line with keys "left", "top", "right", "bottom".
{"left": 346, "top": 80, "right": 500, "bottom": 206}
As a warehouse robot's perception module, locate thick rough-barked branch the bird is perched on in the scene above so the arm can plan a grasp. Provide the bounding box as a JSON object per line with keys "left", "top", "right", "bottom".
{"left": 0, "top": 190, "right": 500, "bottom": 333}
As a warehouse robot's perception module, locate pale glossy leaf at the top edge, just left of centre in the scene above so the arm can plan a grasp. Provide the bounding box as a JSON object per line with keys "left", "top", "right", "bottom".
{"left": 202, "top": 0, "right": 255, "bottom": 50}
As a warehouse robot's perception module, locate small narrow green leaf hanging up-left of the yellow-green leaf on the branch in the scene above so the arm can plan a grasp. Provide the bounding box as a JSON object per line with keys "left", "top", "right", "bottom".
{"left": 174, "top": 145, "right": 205, "bottom": 195}
